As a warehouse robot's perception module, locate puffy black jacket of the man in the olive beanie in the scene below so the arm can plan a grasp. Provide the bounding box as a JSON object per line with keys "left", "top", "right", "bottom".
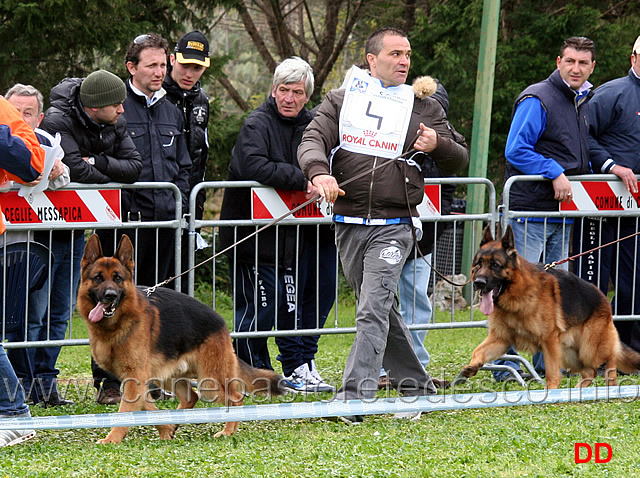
{"left": 40, "top": 78, "right": 142, "bottom": 183}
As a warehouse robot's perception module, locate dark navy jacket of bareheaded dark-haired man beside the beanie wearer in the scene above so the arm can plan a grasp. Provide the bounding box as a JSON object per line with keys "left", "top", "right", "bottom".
{"left": 122, "top": 81, "right": 191, "bottom": 221}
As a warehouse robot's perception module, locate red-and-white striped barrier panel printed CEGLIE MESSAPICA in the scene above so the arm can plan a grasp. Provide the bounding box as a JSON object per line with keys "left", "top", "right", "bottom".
{"left": 0, "top": 189, "right": 122, "bottom": 225}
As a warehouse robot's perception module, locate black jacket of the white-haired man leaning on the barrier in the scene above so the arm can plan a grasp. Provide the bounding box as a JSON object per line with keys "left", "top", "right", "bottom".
{"left": 220, "top": 95, "right": 316, "bottom": 267}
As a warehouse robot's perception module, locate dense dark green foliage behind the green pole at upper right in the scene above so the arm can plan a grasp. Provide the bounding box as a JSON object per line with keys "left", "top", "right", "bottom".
{"left": 410, "top": 0, "right": 640, "bottom": 189}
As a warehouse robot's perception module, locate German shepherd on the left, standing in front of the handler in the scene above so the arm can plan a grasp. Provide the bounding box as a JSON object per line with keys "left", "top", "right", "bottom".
{"left": 77, "top": 234, "right": 282, "bottom": 443}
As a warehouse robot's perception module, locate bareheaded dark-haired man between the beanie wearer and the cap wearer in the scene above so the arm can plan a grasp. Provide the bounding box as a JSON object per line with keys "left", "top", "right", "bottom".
{"left": 100, "top": 33, "right": 191, "bottom": 286}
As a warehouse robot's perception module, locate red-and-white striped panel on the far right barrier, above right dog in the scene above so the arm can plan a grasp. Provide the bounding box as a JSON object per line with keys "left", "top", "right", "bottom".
{"left": 560, "top": 181, "right": 640, "bottom": 211}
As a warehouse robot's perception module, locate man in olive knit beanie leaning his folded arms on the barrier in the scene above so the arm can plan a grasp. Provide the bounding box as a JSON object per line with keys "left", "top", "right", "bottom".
{"left": 40, "top": 70, "right": 142, "bottom": 405}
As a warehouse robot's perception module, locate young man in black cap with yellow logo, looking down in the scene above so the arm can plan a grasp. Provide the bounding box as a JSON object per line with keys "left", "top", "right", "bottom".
{"left": 162, "top": 31, "right": 211, "bottom": 292}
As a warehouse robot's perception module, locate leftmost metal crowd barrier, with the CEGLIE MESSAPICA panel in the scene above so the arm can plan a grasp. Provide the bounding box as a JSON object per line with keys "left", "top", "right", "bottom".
{"left": 0, "top": 182, "right": 186, "bottom": 349}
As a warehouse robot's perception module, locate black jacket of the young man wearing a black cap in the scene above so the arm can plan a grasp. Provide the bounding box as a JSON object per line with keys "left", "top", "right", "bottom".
{"left": 162, "top": 65, "right": 209, "bottom": 219}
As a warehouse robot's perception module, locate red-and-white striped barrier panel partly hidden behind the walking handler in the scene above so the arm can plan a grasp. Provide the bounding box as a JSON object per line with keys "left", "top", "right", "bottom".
{"left": 251, "top": 184, "right": 440, "bottom": 219}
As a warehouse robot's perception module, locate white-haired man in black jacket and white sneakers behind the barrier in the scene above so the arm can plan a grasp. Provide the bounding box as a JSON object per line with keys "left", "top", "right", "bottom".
{"left": 220, "top": 57, "right": 336, "bottom": 393}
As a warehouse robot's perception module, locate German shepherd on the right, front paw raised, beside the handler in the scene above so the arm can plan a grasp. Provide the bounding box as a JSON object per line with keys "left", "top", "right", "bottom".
{"left": 456, "top": 226, "right": 640, "bottom": 389}
